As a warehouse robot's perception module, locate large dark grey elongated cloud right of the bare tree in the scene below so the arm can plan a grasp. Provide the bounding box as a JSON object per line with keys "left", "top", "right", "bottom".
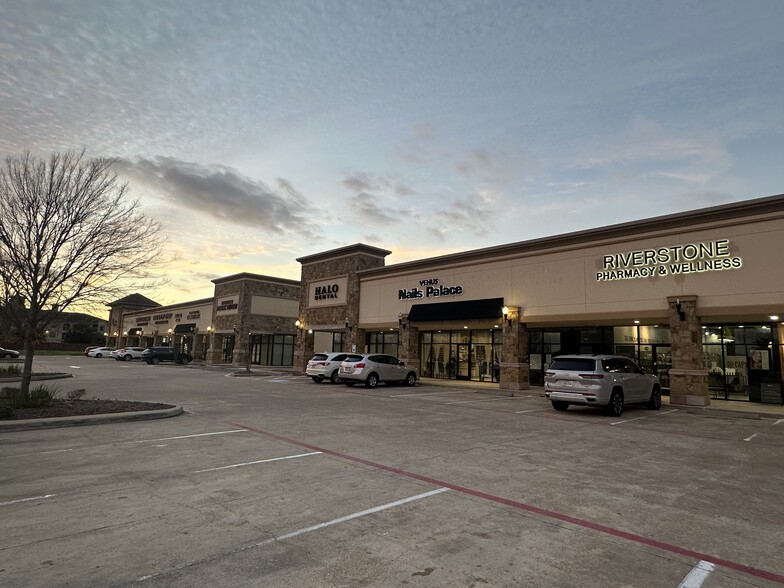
{"left": 117, "top": 157, "right": 319, "bottom": 238}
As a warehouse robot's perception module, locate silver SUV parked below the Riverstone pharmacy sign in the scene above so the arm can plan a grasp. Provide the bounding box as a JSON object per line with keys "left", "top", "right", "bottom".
{"left": 544, "top": 355, "right": 661, "bottom": 417}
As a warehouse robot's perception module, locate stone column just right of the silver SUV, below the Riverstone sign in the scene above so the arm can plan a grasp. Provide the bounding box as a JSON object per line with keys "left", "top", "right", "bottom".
{"left": 667, "top": 296, "right": 710, "bottom": 406}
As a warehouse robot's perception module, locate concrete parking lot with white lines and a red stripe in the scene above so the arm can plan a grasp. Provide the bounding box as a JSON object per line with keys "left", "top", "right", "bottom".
{"left": 0, "top": 357, "right": 784, "bottom": 587}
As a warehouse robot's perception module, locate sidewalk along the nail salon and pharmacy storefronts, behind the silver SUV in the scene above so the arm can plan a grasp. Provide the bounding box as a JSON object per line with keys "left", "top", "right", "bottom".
{"left": 419, "top": 378, "right": 784, "bottom": 419}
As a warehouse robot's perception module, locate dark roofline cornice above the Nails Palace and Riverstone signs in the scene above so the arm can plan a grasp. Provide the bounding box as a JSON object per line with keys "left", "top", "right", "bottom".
{"left": 357, "top": 194, "right": 784, "bottom": 277}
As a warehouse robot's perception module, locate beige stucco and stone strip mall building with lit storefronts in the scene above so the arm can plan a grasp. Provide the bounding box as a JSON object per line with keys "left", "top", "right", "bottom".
{"left": 110, "top": 195, "right": 784, "bottom": 406}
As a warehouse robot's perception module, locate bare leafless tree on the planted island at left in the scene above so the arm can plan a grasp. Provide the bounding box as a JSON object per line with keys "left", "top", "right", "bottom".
{"left": 0, "top": 151, "right": 162, "bottom": 393}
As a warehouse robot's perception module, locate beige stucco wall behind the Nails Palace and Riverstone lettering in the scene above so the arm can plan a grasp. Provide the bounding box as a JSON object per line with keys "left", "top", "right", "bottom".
{"left": 359, "top": 218, "right": 784, "bottom": 326}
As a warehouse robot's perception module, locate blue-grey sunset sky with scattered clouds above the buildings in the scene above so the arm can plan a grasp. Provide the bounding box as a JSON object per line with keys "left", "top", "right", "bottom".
{"left": 0, "top": 0, "right": 784, "bottom": 304}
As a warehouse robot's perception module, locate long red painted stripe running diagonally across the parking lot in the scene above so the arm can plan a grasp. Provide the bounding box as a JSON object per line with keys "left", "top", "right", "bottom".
{"left": 216, "top": 419, "right": 784, "bottom": 584}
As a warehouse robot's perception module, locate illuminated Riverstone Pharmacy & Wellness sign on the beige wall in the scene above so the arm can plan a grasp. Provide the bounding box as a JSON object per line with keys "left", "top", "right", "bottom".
{"left": 596, "top": 239, "right": 743, "bottom": 282}
